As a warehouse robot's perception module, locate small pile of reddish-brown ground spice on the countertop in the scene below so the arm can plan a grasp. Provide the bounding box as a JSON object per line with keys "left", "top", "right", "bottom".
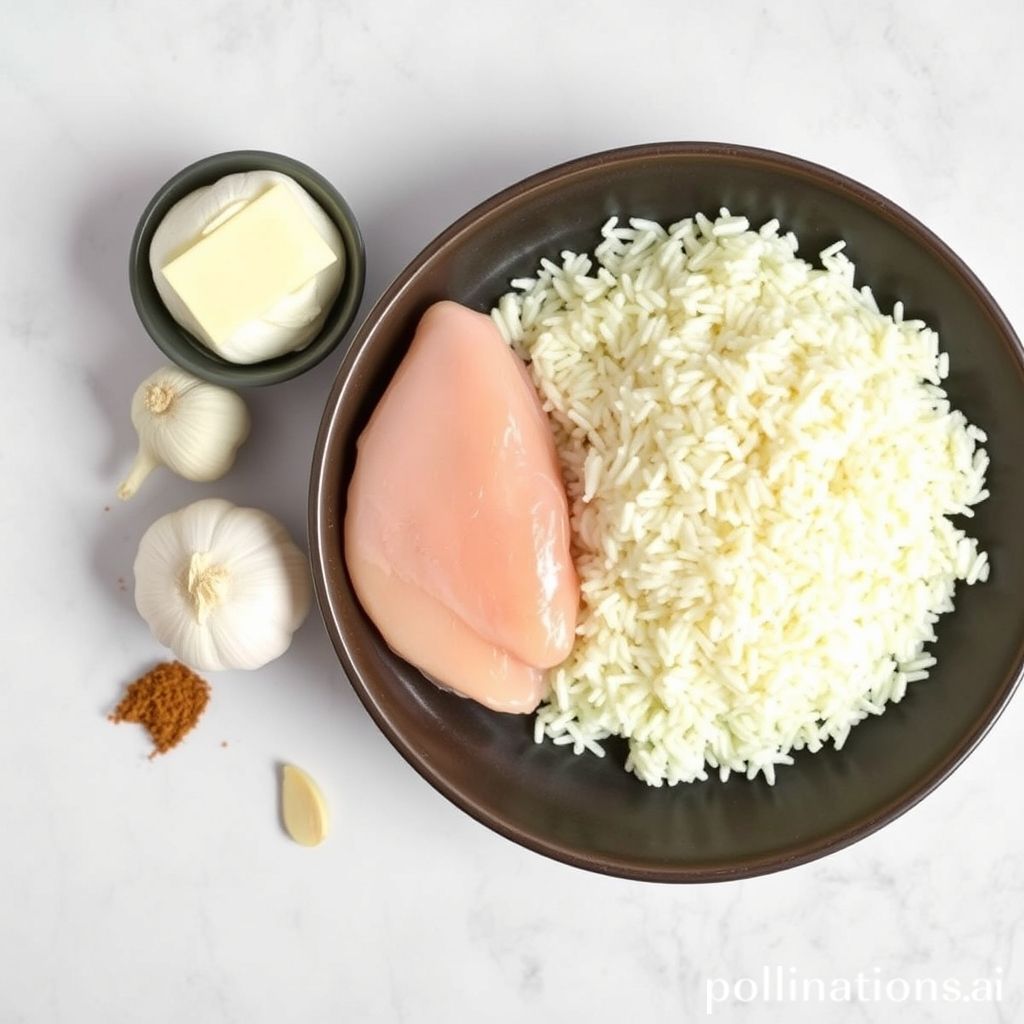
{"left": 110, "top": 662, "right": 210, "bottom": 758}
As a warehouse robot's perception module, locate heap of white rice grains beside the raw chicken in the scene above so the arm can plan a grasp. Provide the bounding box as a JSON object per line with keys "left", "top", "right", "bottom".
{"left": 493, "top": 210, "right": 988, "bottom": 785}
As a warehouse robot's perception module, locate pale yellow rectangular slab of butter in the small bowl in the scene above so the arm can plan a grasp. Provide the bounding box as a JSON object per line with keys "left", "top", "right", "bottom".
{"left": 163, "top": 184, "right": 338, "bottom": 344}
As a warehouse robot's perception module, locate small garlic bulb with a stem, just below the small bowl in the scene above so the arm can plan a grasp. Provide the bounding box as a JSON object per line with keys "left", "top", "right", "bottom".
{"left": 118, "top": 367, "right": 250, "bottom": 501}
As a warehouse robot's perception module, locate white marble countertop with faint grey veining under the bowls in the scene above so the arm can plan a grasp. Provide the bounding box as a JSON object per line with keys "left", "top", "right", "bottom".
{"left": 0, "top": 0, "right": 1024, "bottom": 1024}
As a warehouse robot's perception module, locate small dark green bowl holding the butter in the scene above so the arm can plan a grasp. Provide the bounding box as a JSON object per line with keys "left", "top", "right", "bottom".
{"left": 128, "top": 150, "right": 367, "bottom": 387}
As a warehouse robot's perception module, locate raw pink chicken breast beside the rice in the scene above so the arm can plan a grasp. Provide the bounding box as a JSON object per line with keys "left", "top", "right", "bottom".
{"left": 345, "top": 302, "right": 580, "bottom": 712}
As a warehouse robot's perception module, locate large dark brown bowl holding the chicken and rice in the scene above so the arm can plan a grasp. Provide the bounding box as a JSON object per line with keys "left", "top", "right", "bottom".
{"left": 309, "top": 143, "right": 1024, "bottom": 882}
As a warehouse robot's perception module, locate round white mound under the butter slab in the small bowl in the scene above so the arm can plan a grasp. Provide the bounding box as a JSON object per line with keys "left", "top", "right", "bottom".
{"left": 150, "top": 171, "right": 345, "bottom": 364}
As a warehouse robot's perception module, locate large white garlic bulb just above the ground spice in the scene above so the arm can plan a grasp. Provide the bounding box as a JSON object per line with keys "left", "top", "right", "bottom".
{"left": 135, "top": 498, "right": 310, "bottom": 672}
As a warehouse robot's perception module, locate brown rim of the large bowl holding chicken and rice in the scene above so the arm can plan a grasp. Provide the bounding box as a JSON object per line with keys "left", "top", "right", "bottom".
{"left": 307, "top": 141, "right": 1024, "bottom": 883}
